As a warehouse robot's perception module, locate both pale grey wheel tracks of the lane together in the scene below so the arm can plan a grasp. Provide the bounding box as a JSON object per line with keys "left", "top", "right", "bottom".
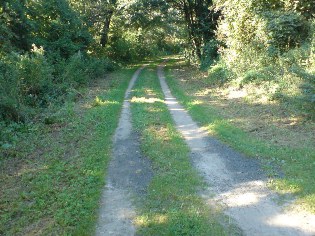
{"left": 96, "top": 64, "right": 315, "bottom": 235}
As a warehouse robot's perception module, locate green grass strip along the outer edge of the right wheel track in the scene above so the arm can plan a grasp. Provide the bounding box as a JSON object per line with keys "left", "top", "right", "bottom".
{"left": 167, "top": 58, "right": 315, "bottom": 213}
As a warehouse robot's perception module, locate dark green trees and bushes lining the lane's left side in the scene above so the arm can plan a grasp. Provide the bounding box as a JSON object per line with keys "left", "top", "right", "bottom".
{"left": 0, "top": 0, "right": 115, "bottom": 122}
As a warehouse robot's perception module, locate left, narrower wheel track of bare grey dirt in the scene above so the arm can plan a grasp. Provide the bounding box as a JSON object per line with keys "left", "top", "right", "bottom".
{"left": 96, "top": 67, "right": 152, "bottom": 236}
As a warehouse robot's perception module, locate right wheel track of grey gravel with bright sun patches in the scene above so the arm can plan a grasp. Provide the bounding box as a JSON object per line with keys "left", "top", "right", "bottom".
{"left": 158, "top": 65, "right": 315, "bottom": 235}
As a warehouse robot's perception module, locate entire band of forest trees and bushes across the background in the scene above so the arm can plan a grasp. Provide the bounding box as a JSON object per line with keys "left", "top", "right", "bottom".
{"left": 0, "top": 0, "right": 315, "bottom": 125}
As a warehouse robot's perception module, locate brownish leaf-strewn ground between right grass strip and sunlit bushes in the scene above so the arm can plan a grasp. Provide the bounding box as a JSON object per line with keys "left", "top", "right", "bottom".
{"left": 188, "top": 82, "right": 315, "bottom": 148}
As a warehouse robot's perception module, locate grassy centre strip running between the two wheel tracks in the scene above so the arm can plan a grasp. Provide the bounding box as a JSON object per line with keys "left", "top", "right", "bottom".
{"left": 131, "top": 66, "right": 232, "bottom": 235}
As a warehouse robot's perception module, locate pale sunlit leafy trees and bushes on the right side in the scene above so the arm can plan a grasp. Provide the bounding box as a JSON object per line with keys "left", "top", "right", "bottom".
{"left": 209, "top": 0, "right": 315, "bottom": 115}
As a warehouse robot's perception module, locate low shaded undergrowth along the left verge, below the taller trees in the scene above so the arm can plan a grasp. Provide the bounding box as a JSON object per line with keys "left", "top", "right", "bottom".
{"left": 0, "top": 48, "right": 115, "bottom": 122}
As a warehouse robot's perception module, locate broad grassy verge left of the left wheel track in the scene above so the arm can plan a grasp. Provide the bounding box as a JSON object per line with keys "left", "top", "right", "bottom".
{"left": 0, "top": 69, "right": 134, "bottom": 235}
